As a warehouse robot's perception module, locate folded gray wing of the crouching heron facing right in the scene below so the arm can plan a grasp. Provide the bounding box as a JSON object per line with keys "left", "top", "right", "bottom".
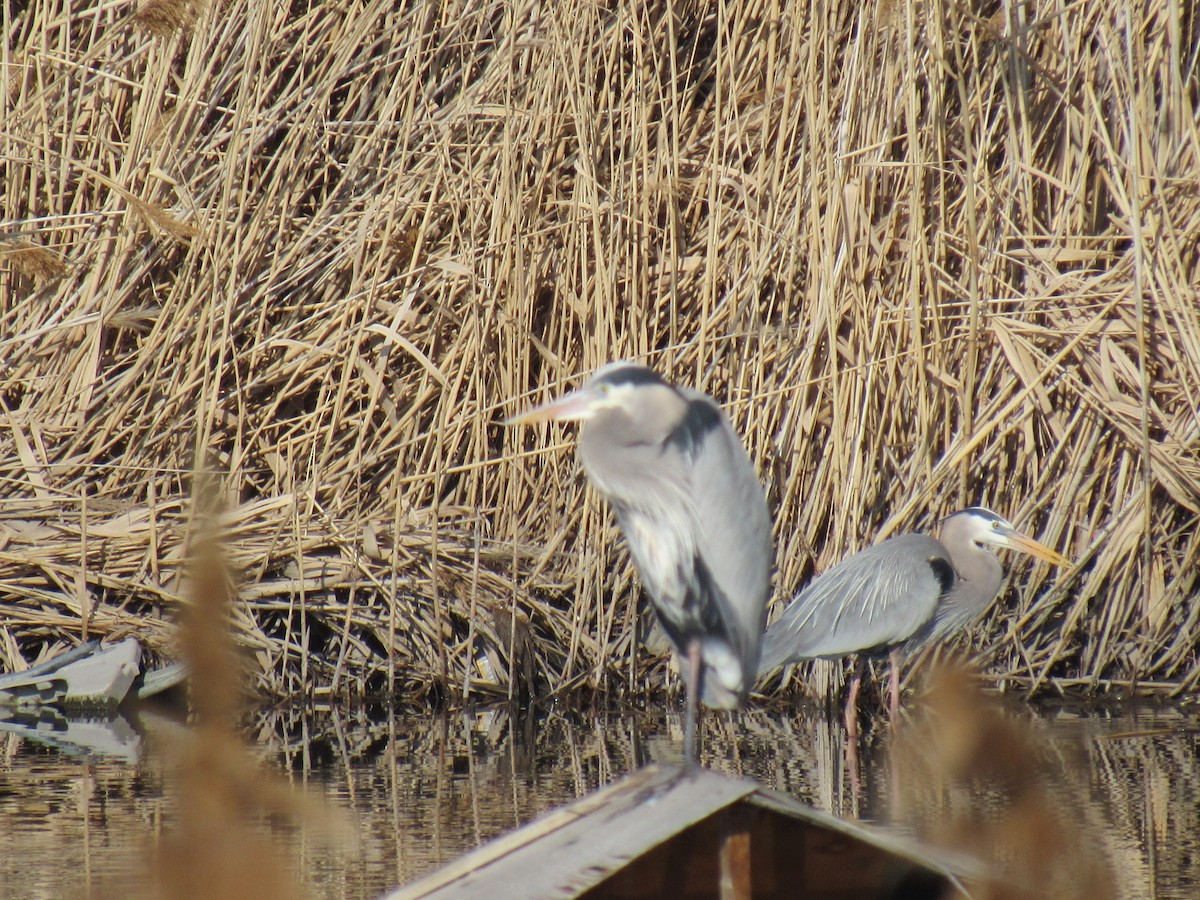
{"left": 758, "top": 534, "right": 955, "bottom": 673}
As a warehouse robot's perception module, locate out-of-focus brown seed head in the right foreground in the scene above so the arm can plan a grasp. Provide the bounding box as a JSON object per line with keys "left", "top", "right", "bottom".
{"left": 893, "top": 668, "right": 1117, "bottom": 900}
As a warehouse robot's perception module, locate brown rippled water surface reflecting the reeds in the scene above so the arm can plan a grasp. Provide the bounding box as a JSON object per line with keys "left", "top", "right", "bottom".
{"left": 0, "top": 706, "right": 1200, "bottom": 898}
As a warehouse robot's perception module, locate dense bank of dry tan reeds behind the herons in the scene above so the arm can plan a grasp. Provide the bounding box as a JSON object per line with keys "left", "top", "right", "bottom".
{"left": 0, "top": 0, "right": 1200, "bottom": 702}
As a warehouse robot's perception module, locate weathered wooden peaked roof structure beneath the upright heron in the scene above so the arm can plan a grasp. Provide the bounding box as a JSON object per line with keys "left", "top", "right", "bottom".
{"left": 386, "top": 767, "right": 967, "bottom": 900}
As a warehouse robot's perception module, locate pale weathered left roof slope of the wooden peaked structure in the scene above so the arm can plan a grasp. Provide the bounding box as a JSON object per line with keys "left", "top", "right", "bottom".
{"left": 386, "top": 766, "right": 757, "bottom": 900}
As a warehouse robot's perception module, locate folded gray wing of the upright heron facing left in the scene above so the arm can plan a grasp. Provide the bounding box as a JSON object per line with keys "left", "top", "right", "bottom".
{"left": 672, "top": 389, "right": 775, "bottom": 707}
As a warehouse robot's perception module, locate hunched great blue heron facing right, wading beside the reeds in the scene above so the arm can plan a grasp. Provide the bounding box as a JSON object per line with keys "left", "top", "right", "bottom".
{"left": 758, "top": 506, "right": 1070, "bottom": 737}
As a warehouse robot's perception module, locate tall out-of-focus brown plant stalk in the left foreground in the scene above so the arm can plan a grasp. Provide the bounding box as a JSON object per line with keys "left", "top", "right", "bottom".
{"left": 155, "top": 528, "right": 343, "bottom": 900}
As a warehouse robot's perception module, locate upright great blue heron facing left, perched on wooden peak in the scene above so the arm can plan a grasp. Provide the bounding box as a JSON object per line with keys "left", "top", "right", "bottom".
{"left": 509, "top": 362, "right": 774, "bottom": 763}
